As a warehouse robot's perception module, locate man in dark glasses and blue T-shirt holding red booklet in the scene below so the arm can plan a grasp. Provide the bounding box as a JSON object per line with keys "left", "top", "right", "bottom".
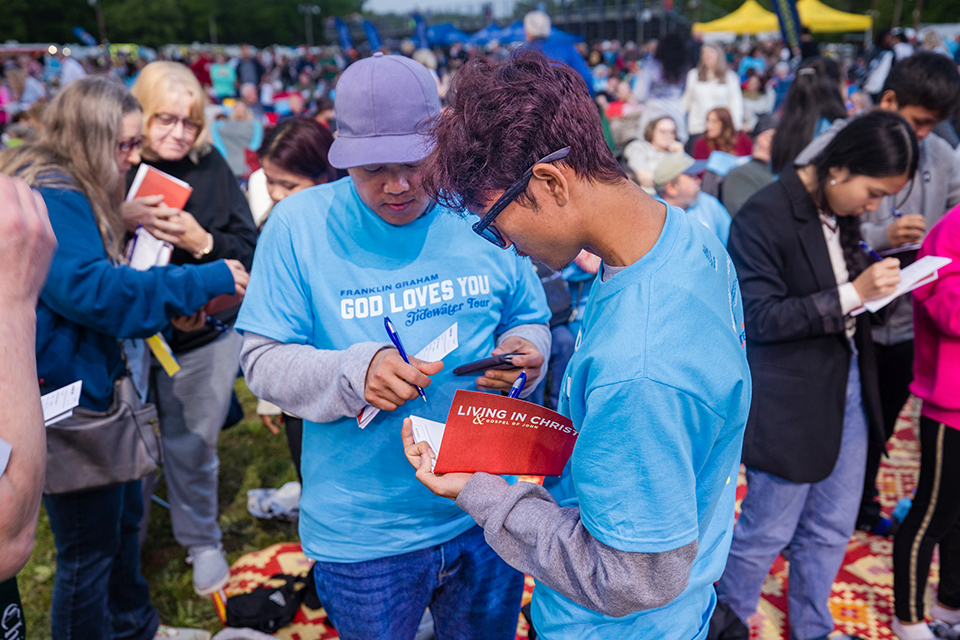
{"left": 403, "top": 51, "right": 750, "bottom": 640}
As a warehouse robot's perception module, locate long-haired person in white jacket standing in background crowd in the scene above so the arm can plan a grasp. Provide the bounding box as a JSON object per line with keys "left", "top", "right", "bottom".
{"left": 683, "top": 44, "right": 743, "bottom": 138}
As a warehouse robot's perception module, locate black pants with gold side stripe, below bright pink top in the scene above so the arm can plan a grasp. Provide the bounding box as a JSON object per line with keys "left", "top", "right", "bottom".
{"left": 893, "top": 416, "right": 960, "bottom": 623}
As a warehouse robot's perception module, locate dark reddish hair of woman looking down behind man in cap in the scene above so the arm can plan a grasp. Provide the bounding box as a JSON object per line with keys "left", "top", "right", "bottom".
{"left": 257, "top": 117, "right": 339, "bottom": 184}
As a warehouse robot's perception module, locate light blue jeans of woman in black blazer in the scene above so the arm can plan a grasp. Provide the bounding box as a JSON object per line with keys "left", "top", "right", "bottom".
{"left": 717, "top": 357, "right": 869, "bottom": 640}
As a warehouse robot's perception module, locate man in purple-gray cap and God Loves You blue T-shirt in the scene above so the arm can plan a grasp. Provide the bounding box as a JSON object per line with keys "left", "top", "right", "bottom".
{"left": 237, "top": 53, "right": 550, "bottom": 640}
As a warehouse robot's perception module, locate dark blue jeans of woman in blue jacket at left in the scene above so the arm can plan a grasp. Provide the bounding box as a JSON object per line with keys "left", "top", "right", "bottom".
{"left": 43, "top": 480, "right": 160, "bottom": 640}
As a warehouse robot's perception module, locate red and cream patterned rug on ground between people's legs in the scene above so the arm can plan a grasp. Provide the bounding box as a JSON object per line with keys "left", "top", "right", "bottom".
{"left": 226, "top": 403, "right": 924, "bottom": 640}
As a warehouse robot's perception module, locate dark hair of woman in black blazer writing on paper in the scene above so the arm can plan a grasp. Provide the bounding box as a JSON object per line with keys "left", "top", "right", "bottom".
{"left": 810, "top": 110, "right": 920, "bottom": 280}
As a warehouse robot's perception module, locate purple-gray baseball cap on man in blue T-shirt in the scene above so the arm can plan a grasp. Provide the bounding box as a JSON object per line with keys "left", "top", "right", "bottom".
{"left": 328, "top": 52, "right": 440, "bottom": 169}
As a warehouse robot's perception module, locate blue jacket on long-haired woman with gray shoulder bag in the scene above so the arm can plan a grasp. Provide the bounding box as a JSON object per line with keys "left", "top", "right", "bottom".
{"left": 37, "top": 189, "right": 234, "bottom": 411}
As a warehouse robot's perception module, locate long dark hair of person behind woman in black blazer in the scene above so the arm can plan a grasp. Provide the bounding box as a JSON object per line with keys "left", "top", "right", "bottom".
{"left": 770, "top": 58, "right": 847, "bottom": 173}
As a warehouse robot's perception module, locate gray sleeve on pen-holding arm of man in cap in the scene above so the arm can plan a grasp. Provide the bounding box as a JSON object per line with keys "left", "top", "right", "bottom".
{"left": 240, "top": 332, "right": 390, "bottom": 422}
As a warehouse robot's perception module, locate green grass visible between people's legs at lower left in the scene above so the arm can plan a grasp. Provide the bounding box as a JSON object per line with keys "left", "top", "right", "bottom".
{"left": 18, "top": 380, "right": 299, "bottom": 640}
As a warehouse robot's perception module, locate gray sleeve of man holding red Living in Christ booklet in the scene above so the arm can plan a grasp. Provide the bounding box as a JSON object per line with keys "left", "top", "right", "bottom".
{"left": 457, "top": 473, "right": 698, "bottom": 617}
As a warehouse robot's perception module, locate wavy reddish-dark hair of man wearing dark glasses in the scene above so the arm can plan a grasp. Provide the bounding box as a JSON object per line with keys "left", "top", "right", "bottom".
{"left": 423, "top": 48, "right": 626, "bottom": 211}
